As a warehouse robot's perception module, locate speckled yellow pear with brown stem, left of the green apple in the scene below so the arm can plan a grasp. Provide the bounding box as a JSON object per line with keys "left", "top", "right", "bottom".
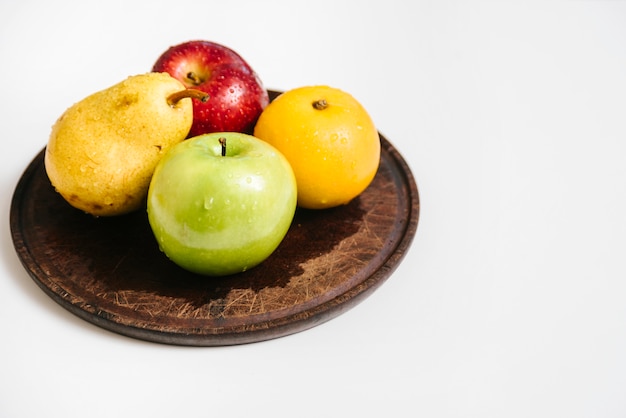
{"left": 45, "top": 72, "right": 208, "bottom": 216}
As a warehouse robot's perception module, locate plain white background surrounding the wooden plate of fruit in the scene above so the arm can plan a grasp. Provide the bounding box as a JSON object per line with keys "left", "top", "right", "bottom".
{"left": 0, "top": 0, "right": 626, "bottom": 418}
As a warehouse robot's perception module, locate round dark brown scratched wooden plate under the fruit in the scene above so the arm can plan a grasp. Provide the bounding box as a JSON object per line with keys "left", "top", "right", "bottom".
{"left": 10, "top": 99, "right": 419, "bottom": 346}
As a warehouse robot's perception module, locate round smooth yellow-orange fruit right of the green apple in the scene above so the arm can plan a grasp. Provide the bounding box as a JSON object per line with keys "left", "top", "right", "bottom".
{"left": 254, "top": 86, "right": 380, "bottom": 209}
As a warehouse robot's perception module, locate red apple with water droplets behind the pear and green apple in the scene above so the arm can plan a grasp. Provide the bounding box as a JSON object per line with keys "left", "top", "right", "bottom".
{"left": 152, "top": 40, "right": 269, "bottom": 137}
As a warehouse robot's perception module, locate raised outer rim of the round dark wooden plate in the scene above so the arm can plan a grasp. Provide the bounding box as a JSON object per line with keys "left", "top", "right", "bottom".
{"left": 10, "top": 132, "right": 420, "bottom": 346}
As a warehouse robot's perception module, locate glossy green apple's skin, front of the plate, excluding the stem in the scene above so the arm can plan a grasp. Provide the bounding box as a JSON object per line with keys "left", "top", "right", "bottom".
{"left": 147, "top": 132, "right": 297, "bottom": 276}
